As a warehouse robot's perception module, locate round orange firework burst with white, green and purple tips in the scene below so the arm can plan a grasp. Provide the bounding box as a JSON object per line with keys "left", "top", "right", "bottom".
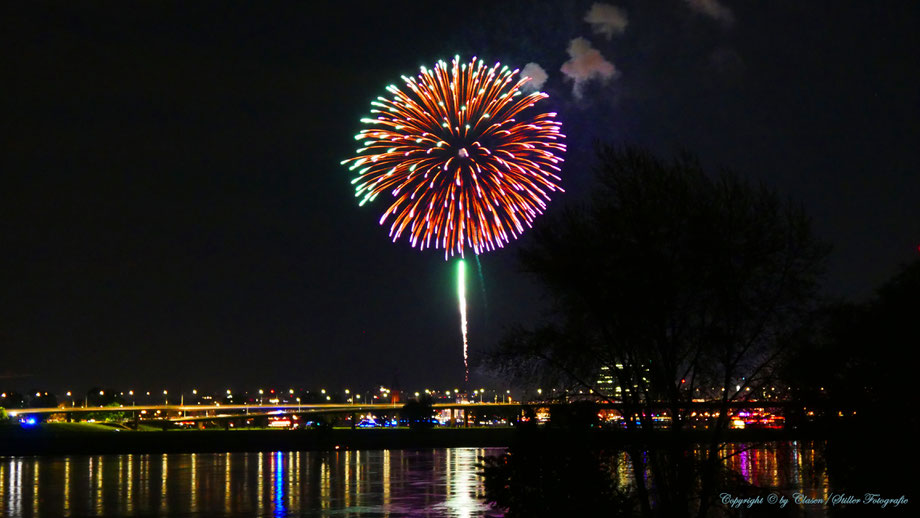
{"left": 342, "top": 57, "right": 565, "bottom": 259}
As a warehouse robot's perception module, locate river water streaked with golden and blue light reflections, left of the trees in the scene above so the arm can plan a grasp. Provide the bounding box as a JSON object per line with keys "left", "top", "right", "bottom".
{"left": 0, "top": 448, "right": 504, "bottom": 518}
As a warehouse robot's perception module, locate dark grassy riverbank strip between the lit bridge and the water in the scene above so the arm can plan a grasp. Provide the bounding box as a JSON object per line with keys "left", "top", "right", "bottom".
{"left": 0, "top": 428, "right": 832, "bottom": 455}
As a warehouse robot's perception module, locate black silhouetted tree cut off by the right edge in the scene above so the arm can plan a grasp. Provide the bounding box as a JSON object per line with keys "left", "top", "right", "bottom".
{"left": 782, "top": 260, "right": 920, "bottom": 502}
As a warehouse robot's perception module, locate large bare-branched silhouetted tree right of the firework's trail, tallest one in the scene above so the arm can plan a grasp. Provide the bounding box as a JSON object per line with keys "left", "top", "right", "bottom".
{"left": 490, "top": 147, "right": 828, "bottom": 516}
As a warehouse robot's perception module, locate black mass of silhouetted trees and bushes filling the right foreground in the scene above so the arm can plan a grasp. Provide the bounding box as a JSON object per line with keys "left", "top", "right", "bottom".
{"left": 483, "top": 147, "right": 920, "bottom": 518}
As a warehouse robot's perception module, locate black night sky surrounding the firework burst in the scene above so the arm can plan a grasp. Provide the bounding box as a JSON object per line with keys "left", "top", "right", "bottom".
{"left": 0, "top": 0, "right": 920, "bottom": 390}
